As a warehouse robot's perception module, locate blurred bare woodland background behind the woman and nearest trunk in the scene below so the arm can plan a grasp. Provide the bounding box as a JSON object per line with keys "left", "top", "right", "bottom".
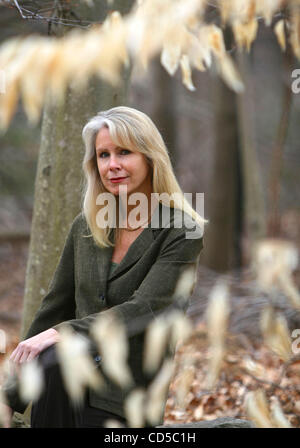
{"left": 0, "top": 0, "right": 300, "bottom": 423}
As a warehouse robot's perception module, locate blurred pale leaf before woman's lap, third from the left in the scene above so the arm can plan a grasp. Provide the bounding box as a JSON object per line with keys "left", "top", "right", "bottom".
{"left": 91, "top": 314, "right": 133, "bottom": 387}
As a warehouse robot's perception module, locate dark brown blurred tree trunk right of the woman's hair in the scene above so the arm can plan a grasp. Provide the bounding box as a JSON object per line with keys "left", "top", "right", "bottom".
{"left": 202, "top": 74, "right": 240, "bottom": 272}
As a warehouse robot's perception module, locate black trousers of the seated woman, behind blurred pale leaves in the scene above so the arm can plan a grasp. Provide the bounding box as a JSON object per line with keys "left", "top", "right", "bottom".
{"left": 31, "top": 345, "right": 126, "bottom": 428}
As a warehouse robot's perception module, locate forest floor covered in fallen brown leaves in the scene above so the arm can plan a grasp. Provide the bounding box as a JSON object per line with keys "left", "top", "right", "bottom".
{"left": 0, "top": 241, "right": 300, "bottom": 427}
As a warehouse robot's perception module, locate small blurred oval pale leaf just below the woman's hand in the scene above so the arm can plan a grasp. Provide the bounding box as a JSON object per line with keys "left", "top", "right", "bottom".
{"left": 19, "top": 358, "right": 44, "bottom": 403}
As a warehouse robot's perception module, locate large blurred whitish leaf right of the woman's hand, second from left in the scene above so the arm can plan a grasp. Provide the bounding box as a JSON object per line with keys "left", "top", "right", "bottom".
{"left": 57, "top": 326, "right": 104, "bottom": 403}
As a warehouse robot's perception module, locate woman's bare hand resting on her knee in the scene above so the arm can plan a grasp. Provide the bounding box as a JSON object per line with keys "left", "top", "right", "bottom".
{"left": 9, "top": 328, "right": 59, "bottom": 364}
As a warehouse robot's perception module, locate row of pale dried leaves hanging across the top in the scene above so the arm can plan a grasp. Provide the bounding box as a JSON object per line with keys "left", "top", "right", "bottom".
{"left": 0, "top": 0, "right": 290, "bottom": 128}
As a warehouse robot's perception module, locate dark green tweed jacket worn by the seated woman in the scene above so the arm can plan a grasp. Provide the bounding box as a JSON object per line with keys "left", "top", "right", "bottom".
{"left": 4, "top": 203, "right": 203, "bottom": 422}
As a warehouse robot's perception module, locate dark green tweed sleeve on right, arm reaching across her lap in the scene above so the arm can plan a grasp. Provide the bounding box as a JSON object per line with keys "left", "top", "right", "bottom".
{"left": 55, "top": 229, "right": 203, "bottom": 335}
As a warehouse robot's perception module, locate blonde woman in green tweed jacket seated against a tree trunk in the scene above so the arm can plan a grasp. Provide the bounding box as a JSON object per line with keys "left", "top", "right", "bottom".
{"left": 1, "top": 107, "right": 204, "bottom": 427}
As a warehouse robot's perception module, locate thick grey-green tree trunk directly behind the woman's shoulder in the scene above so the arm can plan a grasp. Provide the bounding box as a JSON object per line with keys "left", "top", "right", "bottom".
{"left": 21, "top": 0, "right": 133, "bottom": 337}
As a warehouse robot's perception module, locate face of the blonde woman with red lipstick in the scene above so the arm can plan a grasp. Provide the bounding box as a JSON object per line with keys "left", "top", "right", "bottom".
{"left": 95, "top": 127, "right": 152, "bottom": 195}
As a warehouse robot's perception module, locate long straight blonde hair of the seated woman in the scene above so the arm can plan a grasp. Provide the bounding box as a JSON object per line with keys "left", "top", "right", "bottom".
{"left": 82, "top": 106, "right": 207, "bottom": 247}
